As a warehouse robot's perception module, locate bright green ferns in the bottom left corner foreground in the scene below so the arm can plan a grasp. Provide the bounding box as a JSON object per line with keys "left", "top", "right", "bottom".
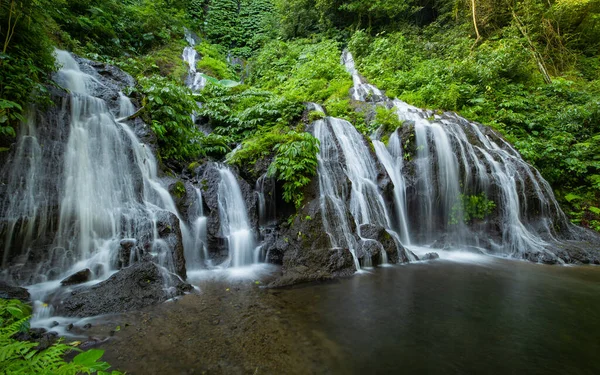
{"left": 0, "top": 299, "right": 122, "bottom": 375}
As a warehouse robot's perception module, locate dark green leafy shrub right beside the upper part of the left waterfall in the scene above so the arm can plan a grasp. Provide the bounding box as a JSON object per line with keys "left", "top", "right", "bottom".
{"left": 139, "top": 76, "right": 202, "bottom": 161}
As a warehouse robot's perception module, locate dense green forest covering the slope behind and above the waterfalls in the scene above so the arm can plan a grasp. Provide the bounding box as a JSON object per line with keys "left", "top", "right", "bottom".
{"left": 0, "top": 0, "right": 600, "bottom": 230}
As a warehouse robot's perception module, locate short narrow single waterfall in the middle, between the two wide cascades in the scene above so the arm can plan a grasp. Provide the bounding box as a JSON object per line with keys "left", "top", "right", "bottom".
{"left": 218, "top": 167, "right": 255, "bottom": 267}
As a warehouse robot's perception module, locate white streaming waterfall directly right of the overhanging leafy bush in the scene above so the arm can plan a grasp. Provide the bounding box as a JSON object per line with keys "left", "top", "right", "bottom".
{"left": 314, "top": 117, "right": 398, "bottom": 270}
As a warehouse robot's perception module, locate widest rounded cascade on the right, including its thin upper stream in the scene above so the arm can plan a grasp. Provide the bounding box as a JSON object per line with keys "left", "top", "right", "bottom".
{"left": 342, "top": 51, "right": 569, "bottom": 258}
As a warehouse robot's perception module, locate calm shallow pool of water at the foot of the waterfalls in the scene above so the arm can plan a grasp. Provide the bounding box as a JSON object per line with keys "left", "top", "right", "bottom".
{"left": 95, "top": 256, "right": 600, "bottom": 375}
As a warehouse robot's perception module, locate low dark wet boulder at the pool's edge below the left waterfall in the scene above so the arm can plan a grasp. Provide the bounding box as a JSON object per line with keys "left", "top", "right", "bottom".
{"left": 58, "top": 262, "right": 192, "bottom": 317}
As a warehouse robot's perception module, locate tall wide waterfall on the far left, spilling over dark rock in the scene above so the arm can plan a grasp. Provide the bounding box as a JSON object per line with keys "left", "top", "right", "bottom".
{"left": 0, "top": 50, "right": 189, "bottom": 283}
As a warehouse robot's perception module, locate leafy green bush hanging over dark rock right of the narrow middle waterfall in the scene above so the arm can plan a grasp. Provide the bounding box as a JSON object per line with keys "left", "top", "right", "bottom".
{"left": 228, "top": 127, "right": 319, "bottom": 208}
